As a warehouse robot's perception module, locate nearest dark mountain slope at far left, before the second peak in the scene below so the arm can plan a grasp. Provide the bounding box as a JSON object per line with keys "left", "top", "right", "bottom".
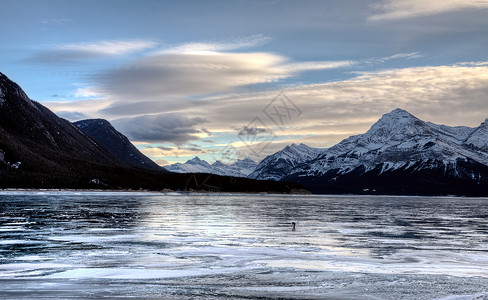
{"left": 0, "top": 73, "right": 154, "bottom": 186}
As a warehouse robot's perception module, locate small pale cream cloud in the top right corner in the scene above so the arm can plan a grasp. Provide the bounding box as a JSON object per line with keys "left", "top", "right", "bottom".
{"left": 368, "top": 0, "right": 488, "bottom": 21}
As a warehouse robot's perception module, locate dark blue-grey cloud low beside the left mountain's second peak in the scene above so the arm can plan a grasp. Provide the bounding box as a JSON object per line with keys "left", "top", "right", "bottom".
{"left": 111, "top": 114, "right": 207, "bottom": 145}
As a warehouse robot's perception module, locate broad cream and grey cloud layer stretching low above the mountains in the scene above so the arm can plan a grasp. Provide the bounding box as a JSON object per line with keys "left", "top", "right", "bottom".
{"left": 33, "top": 37, "right": 488, "bottom": 159}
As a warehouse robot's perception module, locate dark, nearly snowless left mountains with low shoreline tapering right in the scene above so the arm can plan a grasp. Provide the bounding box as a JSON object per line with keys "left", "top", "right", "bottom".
{"left": 0, "top": 73, "right": 302, "bottom": 193}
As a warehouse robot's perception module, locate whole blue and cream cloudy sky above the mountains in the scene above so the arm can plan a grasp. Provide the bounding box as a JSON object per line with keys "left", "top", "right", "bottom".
{"left": 0, "top": 0, "right": 488, "bottom": 165}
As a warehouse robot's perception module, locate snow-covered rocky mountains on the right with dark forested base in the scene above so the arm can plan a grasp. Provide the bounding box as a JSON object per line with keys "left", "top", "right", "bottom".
{"left": 166, "top": 109, "right": 488, "bottom": 195}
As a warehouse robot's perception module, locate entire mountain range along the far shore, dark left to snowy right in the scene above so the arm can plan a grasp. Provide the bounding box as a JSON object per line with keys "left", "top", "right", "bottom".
{"left": 0, "top": 73, "right": 488, "bottom": 196}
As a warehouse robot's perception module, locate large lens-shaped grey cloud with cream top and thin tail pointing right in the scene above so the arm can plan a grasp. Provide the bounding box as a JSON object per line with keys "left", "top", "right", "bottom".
{"left": 86, "top": 52, "right": 354, "bottom": 116}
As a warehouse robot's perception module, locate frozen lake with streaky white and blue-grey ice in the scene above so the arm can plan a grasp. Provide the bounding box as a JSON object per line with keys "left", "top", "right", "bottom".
{"left": 0, "top": 192, "right": 488, "bottom": 299}
